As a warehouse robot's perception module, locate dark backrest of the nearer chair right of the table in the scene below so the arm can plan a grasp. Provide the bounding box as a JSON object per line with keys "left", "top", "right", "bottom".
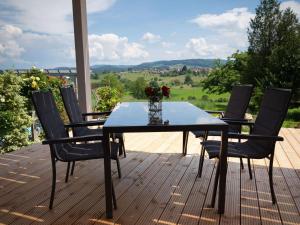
{"left": 248, "top": 88, "right": 292, "bottom": 154}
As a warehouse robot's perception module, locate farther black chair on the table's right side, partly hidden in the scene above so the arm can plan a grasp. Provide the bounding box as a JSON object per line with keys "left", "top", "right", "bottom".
{"left": 193, "top": 85, "right": 253, "bottom": 179}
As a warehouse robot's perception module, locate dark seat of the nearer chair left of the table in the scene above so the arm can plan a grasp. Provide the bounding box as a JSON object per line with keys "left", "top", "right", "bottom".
{"left": 59, "top": 142, "right": 119, "bottom": 162}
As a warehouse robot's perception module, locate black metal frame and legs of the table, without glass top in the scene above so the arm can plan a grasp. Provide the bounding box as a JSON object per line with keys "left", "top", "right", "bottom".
{"left": 103, "top": 111, "right": 228, "bottom": 218}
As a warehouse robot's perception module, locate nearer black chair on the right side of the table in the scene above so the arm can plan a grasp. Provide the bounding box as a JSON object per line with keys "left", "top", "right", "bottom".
{"left": 202, "top": 88, "right": 291, "bottom": 205}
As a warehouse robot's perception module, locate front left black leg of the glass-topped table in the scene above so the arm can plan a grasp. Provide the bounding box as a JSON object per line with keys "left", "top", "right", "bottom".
{"left": 103, "top": 128, "right": 113, "bottom": 219}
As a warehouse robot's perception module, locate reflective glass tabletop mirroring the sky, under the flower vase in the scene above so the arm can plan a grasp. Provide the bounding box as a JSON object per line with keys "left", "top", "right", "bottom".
{"left": 104, "top": 102, "right": 227, "bottom": 128}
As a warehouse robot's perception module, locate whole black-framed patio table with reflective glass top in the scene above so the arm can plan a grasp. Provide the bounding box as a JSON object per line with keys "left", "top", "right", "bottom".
{"left": 103, "top": 102, "right": 228, "bottom": 218}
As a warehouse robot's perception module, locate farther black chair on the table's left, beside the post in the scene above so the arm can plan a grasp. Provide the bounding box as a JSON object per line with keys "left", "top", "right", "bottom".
{"left": 60, "top": 86, "right": 126, "bottom": 180}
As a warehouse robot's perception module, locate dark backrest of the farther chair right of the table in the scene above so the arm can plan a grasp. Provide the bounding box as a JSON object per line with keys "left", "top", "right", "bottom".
{"left": 224, "top": 85, "right": 253, "bottom": 119}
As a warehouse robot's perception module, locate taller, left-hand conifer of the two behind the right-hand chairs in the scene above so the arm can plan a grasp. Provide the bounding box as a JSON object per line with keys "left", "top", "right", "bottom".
{"left": 244, "top": 0, "right": 280, "bottom": 86}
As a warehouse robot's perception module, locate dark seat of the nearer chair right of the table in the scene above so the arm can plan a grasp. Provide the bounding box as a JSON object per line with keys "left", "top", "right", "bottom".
{"left": 201, "top": 141, "right": 269, "bottom": 159}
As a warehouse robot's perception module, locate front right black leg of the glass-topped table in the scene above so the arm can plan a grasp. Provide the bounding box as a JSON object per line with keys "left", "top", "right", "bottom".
{"left": 218, "top": 128, "right": 228, "bottom": 214}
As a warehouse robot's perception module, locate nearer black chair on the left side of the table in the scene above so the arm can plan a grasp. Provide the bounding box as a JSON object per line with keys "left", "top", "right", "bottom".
{"left": 32, "top": 91, "right": 119, "bottom": 209}
